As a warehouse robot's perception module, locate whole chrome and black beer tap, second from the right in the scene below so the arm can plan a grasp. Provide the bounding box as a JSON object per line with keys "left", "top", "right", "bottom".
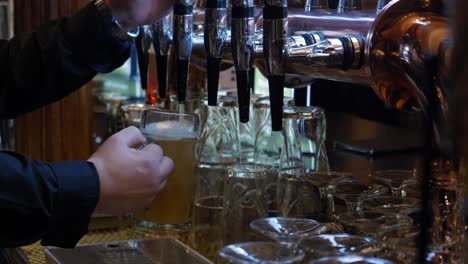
{"left": 231, "top": 0, "right": 255, "bottom": 123}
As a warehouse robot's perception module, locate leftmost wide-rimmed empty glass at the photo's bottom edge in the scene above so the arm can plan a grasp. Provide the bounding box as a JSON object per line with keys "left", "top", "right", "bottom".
{"left": 219, "top": 241, "right": 304, "bottom": 264}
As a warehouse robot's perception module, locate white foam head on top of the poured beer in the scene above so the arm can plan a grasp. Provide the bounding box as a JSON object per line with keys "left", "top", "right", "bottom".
{"left": 141, "top": 120, "right": 197, "bottom": 140}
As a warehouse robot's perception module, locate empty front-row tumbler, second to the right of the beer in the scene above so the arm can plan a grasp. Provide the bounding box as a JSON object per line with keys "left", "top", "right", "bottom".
{"left": 222, "top": 163, "right": 271, "bottom": 245}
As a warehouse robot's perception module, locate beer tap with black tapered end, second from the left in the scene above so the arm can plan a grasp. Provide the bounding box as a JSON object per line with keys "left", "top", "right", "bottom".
{"left": 151, "top": 15, "right": 172, "bottom": 98}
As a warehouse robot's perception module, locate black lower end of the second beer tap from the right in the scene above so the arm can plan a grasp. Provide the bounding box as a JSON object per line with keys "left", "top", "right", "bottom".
{"left": 236, "top": 70, "right": 250, "bottom": 123}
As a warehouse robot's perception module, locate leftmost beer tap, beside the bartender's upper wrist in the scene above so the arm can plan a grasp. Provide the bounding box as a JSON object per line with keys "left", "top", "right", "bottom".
{"left": 135, "top": 25, "right": 151, "bottom": 90}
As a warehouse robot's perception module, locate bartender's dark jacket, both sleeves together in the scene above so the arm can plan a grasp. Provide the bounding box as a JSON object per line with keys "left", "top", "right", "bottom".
{"left": 0, "top": 2, "right": 131, "bottom": 250}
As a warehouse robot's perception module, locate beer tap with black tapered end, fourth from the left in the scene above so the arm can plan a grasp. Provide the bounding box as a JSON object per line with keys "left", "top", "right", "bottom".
{"left": 204, "top": 0, "right": 227, "bottom": 106}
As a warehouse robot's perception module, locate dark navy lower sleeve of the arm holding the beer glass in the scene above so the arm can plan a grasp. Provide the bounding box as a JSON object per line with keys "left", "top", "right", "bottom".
{"left": 0, "top": 152, "right": 99, "bottom": 247}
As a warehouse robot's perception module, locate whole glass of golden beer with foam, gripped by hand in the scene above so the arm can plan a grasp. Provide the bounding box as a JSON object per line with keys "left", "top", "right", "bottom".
{"left": 134, "top": 109, "right": 200, "bottom": 231}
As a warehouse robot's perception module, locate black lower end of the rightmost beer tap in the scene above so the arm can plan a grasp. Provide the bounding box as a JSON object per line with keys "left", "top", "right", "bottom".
{"left": 268, "top": 75, "right": 284, "bottom": 131}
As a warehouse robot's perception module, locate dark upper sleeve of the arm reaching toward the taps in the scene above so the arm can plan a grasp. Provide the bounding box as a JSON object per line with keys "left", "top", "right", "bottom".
{"left": 0, "top": 1, "right": 132, "bottom": 118}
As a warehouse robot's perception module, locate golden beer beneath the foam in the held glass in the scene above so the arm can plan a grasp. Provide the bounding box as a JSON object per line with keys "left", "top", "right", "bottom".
{"left": 135, "top": 120, "right": 197, "bottom": 230}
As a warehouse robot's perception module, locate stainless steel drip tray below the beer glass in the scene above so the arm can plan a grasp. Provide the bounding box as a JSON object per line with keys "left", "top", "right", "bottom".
{"left": 45, "top": 237, "right": 212, "bottom": 264}
